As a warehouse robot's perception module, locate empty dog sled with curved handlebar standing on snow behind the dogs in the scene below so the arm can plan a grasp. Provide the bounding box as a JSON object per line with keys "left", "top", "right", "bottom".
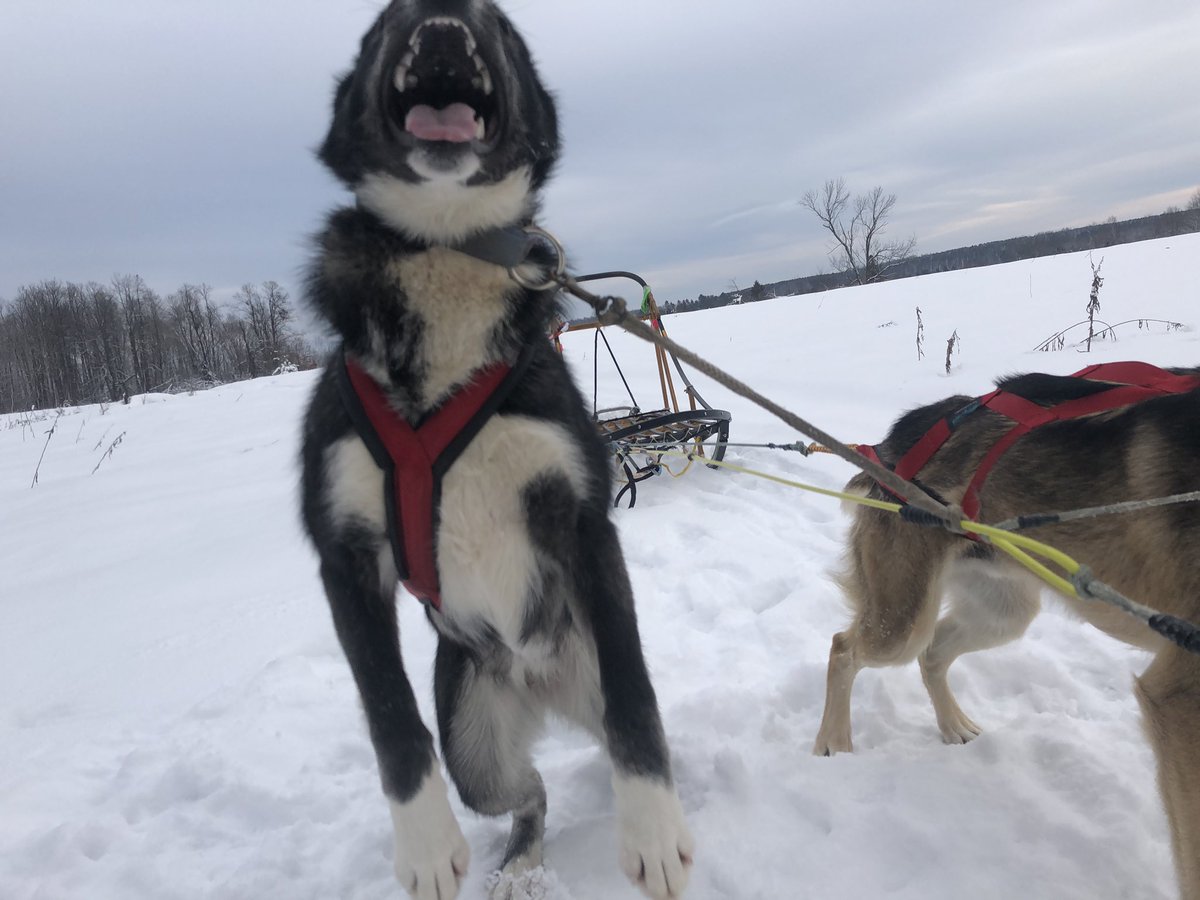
{"left": 552, "top": 271, "right": 731, "bottom": 506}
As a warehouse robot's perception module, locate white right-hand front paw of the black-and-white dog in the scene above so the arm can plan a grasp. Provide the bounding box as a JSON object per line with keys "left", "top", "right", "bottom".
{"left": 613, "top": 775, "right": 695, "bottom": 900}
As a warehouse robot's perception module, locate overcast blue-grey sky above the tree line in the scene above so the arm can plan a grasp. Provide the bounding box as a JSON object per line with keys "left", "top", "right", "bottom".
{"left": 0, "top": 0, "right": 1200, "bottom": 309}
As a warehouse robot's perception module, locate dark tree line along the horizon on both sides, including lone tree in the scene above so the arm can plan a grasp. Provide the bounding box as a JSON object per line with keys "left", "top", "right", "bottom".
{"left": 0, "top": 194, "right": 1200, "bottom": 413}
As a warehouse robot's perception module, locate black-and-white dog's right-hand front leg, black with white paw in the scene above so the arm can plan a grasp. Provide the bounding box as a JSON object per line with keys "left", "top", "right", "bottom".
{"left": 576, "top": 515, "right": 695, "bottom": 900}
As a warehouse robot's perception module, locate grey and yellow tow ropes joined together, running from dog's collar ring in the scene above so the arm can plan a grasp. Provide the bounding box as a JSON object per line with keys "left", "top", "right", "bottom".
{"left": 509, "top": 226, "right": 1200, "bottom": 654}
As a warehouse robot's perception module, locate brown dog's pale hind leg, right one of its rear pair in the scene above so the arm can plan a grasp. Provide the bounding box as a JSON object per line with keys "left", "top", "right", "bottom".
{"left": 919, "top": 559, "right": 1042, "bottom": 744}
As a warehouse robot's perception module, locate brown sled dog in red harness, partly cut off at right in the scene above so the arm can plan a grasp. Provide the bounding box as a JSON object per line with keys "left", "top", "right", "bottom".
{"left": 814, "top": 364, "right": 1200, "bottom": 900}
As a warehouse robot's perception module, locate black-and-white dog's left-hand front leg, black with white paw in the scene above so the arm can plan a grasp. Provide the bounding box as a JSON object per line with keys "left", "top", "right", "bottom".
{"left": 320, "top": 534, "right": 470, "bottom": 900}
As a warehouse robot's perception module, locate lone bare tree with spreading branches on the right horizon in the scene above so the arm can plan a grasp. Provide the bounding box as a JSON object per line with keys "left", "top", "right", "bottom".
{"left": 800, "top": 178, "right": 917, "bottom": 284}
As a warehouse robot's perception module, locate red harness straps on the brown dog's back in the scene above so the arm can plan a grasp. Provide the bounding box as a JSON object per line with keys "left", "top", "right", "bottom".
{"left": 859, "top": 362, "right": 1200, "bottom": 520}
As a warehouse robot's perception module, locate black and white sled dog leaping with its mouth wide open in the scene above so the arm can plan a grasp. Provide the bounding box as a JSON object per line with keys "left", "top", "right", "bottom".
{"left": 302, "top": 0, "right": 692, "bottom": 900}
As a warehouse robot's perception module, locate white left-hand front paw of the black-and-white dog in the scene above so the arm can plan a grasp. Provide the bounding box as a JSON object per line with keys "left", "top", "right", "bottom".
{"left": 391, "top": 764, "right": 470, "bottom": 900}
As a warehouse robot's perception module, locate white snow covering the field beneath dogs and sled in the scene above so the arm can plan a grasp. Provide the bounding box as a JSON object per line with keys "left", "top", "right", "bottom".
{"left": 0, "top": 235, "right": 1200, "bottom": 900}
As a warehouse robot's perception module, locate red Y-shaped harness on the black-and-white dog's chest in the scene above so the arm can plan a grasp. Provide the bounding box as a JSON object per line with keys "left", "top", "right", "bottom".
{"left": 337, "top": 348, "right": 532, "bottom": 610}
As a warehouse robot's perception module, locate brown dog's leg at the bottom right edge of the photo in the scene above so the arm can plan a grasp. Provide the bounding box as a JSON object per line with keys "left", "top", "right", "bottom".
{"left": 1136, "top": 647, "right": 1200, "bottom": 900}
